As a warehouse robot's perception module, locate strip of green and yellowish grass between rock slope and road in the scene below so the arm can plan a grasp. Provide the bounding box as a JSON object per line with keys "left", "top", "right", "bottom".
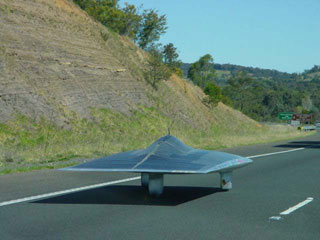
{"left": 0, "top": 107, "right": 310, "bottom": 174}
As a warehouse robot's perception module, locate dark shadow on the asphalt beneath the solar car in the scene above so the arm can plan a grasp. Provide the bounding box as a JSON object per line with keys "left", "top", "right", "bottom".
{"left": 31, "top": 185, "right": 224, "bottom": 206}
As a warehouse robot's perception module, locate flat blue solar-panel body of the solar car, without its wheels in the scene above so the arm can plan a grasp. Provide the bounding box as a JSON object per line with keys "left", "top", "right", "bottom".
{"left": 62, "top": 135, "right": 252, "bottom": 173}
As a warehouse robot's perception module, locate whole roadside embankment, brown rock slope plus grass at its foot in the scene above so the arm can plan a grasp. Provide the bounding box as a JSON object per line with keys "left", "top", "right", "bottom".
{"left": 0, "top": 0, "right": 310, "bottom": 172}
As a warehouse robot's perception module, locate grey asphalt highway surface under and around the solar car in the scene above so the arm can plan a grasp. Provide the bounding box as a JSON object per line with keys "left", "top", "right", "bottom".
{"left": 0, "top": 134, "right": 320, "bottom": 240}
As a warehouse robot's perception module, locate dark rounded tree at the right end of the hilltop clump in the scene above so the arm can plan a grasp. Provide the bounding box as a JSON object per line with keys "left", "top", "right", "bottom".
{"left": 136, "top": 9, "right": 168, "bottom": 49}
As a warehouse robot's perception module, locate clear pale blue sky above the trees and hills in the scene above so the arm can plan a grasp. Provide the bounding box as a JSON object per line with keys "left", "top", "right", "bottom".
{"left": 120, "top": 0, "right": 320, "bottom": 73}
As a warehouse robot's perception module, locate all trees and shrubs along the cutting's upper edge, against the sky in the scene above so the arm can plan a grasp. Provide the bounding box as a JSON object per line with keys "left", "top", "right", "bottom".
{"left": 73, "top": 0, "right": 183, "bottom": 86}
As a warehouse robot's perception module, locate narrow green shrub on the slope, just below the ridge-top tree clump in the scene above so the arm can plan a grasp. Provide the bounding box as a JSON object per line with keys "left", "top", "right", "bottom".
{"left": 144, "top": 45, "right": 171, "bottom": 90}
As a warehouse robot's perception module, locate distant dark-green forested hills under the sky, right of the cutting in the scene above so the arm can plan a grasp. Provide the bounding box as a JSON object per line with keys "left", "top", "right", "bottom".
{"left": 182, "top": 62, "right": 320, "bottom": 122}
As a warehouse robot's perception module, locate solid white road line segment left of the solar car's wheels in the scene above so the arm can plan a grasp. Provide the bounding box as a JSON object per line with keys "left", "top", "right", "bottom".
{"left": 0, "top": 177, "right": 141, "bottom": 207}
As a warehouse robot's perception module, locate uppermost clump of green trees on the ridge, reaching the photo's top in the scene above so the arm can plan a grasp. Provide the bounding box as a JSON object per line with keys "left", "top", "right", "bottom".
{"left": 73, "top": 0, "right": 167, "bottom": 49}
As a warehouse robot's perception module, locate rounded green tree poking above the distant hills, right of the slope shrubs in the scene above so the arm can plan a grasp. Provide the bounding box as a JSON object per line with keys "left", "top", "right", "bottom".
{"left": 188, "top": 54, "right": 215, "bottom": 89}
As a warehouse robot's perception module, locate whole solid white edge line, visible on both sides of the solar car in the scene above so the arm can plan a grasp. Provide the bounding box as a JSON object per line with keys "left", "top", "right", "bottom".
{"left": 0, "top": 145, "right": 304, "bottom": 207}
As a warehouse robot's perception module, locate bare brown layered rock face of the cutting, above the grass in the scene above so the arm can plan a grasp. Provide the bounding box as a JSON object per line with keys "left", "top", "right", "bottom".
{"left": 0, "top": 0, "right": 258, "bottom": 127}
